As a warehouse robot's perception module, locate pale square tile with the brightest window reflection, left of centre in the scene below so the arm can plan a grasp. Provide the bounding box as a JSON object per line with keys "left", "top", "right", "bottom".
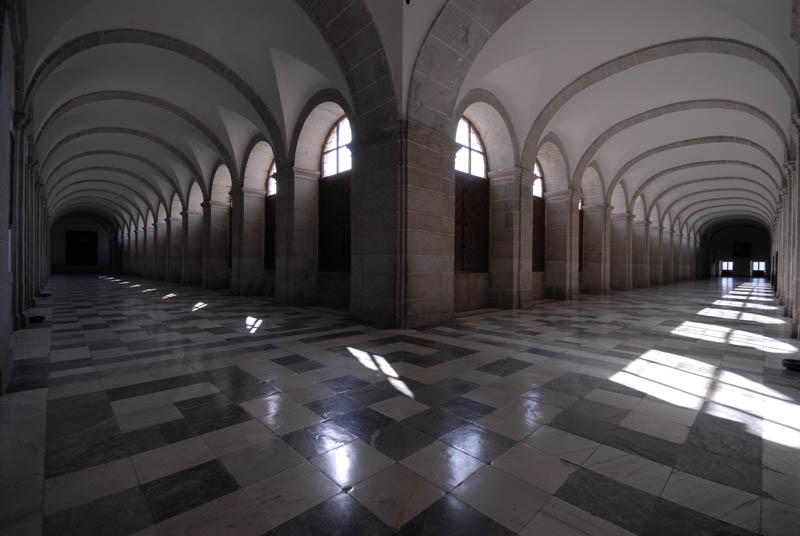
{"left": 311, "top": 439, "right": 394, "bottom": 488}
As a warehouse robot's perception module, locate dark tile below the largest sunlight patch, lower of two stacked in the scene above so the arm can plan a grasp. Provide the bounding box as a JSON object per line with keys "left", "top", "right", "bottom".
{"left": 675, "top": 445, "right": 763, "bottom": 495}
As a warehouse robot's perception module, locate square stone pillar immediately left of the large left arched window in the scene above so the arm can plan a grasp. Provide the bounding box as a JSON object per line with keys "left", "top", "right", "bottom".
{"left": 275, "top": 168, "right": 320, "bottom": 305}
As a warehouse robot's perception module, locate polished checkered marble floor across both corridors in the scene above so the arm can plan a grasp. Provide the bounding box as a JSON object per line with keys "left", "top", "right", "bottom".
{"left": 0, "top": 276, "right": 800, "bottom": 536}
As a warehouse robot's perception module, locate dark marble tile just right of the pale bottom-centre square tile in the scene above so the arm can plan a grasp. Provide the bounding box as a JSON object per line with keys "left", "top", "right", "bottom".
{"left": 555, "top": 467, "right": 660, "bottom": 534}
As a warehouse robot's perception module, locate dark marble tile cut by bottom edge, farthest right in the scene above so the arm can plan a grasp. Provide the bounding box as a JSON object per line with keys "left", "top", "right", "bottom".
{"left": 641, "top": 499, "right": 754, "bottom": 536}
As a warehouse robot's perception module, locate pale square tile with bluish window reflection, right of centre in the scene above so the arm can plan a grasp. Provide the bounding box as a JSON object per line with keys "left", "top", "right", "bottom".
{"left": 401, "top": 441, "right": 485, "bottom": 491}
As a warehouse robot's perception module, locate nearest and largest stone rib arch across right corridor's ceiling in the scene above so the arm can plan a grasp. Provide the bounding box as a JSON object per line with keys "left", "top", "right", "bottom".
{"left": 522, "top": 37, "right": 800, "bottom": 168}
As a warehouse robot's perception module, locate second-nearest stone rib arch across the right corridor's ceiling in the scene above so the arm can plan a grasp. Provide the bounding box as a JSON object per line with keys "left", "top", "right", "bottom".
{"left": 573, "top": 99, "right": 789, "bottom": 187}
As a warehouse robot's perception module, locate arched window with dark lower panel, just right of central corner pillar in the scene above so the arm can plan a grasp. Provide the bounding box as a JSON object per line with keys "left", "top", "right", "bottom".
{"left": 454, "top": 117, "right": 489, "bottom": 272}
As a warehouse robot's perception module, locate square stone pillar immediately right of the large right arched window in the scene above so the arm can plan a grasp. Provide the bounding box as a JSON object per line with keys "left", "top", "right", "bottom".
{"left": 489, "top": 168, "right": 533, "bottom": 308}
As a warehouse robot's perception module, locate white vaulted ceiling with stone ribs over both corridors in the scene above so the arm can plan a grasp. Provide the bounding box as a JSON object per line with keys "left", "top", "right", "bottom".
{"left": 28, "top": 0, "right": 798, "bottom": 239}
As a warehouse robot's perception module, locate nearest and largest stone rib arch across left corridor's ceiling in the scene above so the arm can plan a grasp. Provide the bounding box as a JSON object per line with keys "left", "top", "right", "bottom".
{"left": 23, "top": 28, "right": 288, "bottom": 164}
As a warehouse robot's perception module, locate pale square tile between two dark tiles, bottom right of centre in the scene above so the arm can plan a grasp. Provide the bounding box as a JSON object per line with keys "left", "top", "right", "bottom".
{"left": 453, "top": 467, "right": 550, "bottom": 532}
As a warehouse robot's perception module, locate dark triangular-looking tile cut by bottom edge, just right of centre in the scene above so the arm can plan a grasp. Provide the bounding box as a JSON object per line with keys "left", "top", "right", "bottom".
{"left": 398, "top": 495, "right": 514, "bottom": 536}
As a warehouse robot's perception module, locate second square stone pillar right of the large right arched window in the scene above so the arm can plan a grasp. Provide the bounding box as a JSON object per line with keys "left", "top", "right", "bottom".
{"left": 544, "top": 190, "right": 585, "bottom": 299}
